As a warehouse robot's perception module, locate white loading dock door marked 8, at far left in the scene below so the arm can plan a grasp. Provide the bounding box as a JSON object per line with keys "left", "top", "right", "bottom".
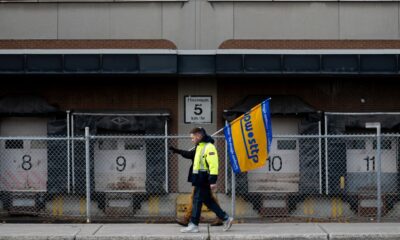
{"left": 0, "top": 117, "right": 47, "bottom": 191}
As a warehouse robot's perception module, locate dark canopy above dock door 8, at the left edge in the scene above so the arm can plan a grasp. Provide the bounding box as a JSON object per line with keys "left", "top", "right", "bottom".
{"left": 0, "top": 95, "right": 60, "bottom": 116}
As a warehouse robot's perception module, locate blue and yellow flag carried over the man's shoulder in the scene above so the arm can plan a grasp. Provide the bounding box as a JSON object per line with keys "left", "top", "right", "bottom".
{"left": 224, "top": 98, "right": 272, "bottom": 173}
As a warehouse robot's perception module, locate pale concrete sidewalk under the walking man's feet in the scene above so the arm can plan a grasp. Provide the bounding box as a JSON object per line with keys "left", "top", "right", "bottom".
{"left": 0, "top": 223, "right": 400, "bottom": 240}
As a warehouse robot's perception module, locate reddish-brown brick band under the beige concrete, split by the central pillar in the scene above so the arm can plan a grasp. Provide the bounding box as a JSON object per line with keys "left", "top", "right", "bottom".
{"left": 0, "top": 39, "right": 400, "bottom": 49}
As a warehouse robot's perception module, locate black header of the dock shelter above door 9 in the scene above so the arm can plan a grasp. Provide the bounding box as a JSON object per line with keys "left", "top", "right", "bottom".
{"left": 72, "top": 109, "right": 170, "bottom": 134}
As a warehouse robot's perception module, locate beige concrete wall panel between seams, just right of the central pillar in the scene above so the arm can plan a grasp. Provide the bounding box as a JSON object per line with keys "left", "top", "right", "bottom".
{"left": 234, "top": 2, "right": 339, "bottom": 39}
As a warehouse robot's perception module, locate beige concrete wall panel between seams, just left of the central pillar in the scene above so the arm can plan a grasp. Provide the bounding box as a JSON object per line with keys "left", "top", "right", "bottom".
{"left": 58, "top": 3, "right": 162, "bottom": 39}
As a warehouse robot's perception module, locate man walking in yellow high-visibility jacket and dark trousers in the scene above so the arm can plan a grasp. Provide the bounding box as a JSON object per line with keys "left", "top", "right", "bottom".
{"left": 181, "top": 128, "right": 233, "bottom": 233}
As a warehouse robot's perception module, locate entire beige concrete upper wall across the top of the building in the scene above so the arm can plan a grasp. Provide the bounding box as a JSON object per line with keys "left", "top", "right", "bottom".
{"left": 0, "top": 0, "right": 400, "bottom": 49}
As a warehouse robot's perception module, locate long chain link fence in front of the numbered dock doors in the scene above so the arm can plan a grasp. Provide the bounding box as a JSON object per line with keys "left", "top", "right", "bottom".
{"left": 0, "top": 132, "right": 400, "bottom": 222}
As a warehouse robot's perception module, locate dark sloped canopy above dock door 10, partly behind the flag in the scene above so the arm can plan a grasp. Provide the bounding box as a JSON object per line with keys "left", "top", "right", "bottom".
{"left": 223, "top": 95, "right": 317, "bottom": 121}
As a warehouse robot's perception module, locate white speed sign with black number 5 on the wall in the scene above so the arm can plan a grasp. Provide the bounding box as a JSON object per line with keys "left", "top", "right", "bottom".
{"left": 185, "top": 96, "right": 212, "bottom": 123}
